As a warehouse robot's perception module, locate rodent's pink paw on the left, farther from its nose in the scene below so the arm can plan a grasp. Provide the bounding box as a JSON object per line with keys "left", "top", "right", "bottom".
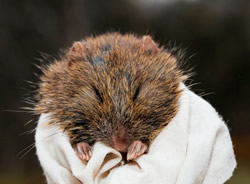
{"left": 74, "top": 142, "right": 92, "bottom": 161}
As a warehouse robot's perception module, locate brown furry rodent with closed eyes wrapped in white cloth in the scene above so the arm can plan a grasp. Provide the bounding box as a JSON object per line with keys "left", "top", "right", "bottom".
{"left": 35, "top": 33, "right": 186, "bottom": 161}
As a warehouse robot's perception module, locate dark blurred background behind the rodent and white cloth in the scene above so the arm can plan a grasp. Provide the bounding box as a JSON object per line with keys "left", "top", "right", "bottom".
{"left": 0, "top": 0, "right": 250, "bottom": 184}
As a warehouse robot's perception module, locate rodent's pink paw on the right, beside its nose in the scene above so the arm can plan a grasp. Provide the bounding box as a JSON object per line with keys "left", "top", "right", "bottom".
{"left": 127, "top": 140, "right": 148, "bottom": 161}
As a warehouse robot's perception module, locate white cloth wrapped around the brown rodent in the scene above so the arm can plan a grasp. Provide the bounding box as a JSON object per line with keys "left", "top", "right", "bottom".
{"left": 35, "top": 85, "right": 236, "bottom": 184}
